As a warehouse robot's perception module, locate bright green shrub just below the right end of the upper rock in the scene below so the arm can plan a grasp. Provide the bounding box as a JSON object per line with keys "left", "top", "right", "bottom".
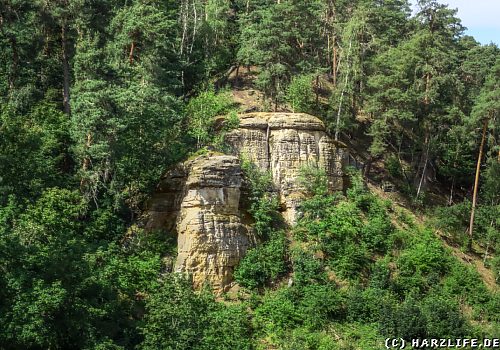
{"left": 295, "top": 168, "right": 395, "bottom": 278}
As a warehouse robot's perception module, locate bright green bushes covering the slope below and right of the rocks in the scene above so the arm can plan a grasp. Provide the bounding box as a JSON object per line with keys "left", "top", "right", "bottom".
{"left": 239, "top": 170, "right": 498, "bottom": 349}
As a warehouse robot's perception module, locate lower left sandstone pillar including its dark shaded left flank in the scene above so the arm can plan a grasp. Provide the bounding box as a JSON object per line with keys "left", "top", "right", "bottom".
{"left": 147, "top": 154, "right": 251, "bottom": 292}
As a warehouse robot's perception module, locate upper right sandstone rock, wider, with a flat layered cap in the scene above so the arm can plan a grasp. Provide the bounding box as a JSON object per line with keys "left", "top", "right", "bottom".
{"left": 227, "top": 113, "right": 345, "bottom": 224}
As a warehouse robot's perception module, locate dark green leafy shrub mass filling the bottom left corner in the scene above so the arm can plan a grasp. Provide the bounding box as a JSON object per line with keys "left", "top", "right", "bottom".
{"left": 0, "top": 188, "right": 125, "bottom": 348}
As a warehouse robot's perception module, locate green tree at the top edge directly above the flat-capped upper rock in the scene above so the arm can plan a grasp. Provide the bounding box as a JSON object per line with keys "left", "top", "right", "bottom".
{"left": 237, "top": 1, "right": 323, "bottom": 110}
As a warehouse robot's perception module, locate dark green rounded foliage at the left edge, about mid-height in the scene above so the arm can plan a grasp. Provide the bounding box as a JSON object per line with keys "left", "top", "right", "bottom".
{"left": 0, "top": 101, "right": 72, "bottom": 205}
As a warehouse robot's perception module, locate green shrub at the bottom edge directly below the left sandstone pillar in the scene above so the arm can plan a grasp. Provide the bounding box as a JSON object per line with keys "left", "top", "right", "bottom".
{"left": 139, "top": 274, "right": 253, "bottom": 350}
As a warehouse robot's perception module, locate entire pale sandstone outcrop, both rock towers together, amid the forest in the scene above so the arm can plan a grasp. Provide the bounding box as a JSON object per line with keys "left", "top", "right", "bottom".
{"left": 146, "top": 113, "right": 344, "bottom": 292}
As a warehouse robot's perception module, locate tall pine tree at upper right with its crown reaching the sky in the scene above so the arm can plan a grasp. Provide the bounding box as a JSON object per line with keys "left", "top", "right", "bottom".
{"left": 367, "top": 1, "right": 462, "bottom": 197}
